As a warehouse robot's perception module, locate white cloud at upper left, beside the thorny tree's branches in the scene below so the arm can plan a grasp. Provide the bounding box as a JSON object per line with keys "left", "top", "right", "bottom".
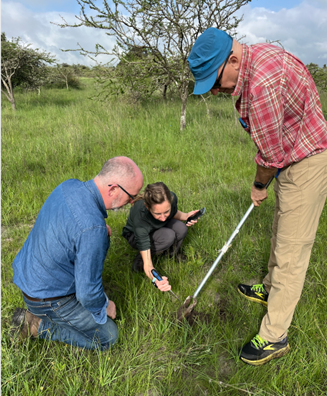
{"left": 1, "top": 2, "right": 115, "bottom": 65}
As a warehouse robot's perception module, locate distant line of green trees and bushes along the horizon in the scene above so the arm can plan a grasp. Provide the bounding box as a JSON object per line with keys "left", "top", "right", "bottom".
{"left": 1, "top": 33, "right": 327, "bottom": 116}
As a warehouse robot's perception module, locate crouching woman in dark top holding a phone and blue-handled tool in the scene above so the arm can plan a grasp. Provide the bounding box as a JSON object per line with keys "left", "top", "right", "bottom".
{"left": 123, "top": 182, "right": 198, "bottom": 291}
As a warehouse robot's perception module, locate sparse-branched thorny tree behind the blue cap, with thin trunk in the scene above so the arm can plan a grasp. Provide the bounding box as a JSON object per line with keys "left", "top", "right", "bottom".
{"left": 55, "top": 0, "right": 251, "bottom": 130}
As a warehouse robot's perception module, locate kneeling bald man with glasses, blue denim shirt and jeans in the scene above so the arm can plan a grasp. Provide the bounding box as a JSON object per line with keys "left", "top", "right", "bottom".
{"left": 12, "top": 157, "right": 143, "bottom": 350}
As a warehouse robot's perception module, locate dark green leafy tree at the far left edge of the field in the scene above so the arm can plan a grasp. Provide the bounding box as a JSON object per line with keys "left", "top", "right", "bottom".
{"left": 1, "top": 33, "right": 55, "bottom": 110}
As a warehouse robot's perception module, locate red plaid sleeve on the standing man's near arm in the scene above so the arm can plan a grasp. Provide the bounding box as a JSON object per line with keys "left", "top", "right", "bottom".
{"left": 249, "top": 86, "right": 285, "bottom": 168}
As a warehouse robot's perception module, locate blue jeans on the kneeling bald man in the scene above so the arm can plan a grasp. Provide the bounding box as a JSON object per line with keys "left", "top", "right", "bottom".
{"left": 23, "top": 294, "right": 118, "bottom": 351}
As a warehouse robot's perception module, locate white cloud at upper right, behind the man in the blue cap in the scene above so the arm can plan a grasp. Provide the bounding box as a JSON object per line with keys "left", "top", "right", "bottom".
{"left": 238, "top": 0, "right": 327, "bottom": 66}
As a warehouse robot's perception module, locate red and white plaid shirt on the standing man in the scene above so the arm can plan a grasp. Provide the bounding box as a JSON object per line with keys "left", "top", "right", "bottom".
{"left": 233, "top": 44, "right": 327, "bottom": 168}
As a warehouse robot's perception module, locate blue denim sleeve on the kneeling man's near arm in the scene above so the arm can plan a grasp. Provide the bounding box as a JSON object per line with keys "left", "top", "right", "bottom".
{"left": 75, "top": 226, "right": 110, "bottom": 324}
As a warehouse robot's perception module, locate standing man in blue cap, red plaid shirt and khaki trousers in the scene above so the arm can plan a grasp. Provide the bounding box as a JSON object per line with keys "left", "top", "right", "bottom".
{"left": 188, "top": 28, "right": 327, "bottom": 365}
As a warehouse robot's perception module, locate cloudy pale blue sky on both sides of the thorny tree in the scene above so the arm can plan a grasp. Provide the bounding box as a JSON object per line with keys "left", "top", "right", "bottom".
{"left": 1, "top": 0, "right": 327, "bottom": 66}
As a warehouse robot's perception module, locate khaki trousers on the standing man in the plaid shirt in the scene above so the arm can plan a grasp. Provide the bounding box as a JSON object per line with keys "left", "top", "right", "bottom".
{"left": 259, "top": 150, "right": 327, "bottom": 342}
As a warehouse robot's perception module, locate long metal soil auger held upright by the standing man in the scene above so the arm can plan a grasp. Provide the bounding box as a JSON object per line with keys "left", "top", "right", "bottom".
{"left": 177, "top": 174, "right": 278, "bottom": 321}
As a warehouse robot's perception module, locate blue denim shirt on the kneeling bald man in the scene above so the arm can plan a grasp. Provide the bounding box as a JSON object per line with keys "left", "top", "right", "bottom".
{"left": 13, "top": 179, "right": 110, "bottom": 324}
